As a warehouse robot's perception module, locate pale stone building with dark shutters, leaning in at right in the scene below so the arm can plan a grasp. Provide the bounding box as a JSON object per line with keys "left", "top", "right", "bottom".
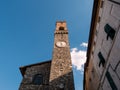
{"left": 83, "top": 0, "right": 120, "bottom": 90}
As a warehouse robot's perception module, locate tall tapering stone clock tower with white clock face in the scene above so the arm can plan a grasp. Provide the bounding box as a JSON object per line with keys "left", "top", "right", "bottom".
{"left": 49, "top": 21, "right": 74, "bottom": 90}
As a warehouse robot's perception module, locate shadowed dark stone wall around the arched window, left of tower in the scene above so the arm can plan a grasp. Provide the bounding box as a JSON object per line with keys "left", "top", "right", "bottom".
{"left": 19, "top": 63, "right": 51, "bottom": 90}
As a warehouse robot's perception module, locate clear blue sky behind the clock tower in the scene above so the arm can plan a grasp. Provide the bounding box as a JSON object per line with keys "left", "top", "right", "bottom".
{"left": 0, "top": 0, "right": 93, "bottom": 90}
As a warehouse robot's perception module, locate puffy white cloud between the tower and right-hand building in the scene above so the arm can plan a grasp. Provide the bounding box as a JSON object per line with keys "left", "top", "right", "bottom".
{"left": 71, "top": 43, "right": 87, "bottom": 71}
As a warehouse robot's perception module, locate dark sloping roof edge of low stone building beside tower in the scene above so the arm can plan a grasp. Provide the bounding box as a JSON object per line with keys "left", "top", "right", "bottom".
{"left": 19, "top": 60, "right": 51, "bottom": 76}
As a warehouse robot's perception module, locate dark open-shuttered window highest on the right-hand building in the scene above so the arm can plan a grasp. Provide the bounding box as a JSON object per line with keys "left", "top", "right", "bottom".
{"left": 104, "top": 24, "right": 115, "bottom": 40}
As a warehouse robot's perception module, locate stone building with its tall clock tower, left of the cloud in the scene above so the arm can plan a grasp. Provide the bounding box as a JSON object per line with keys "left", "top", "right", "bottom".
{"left": 19, "top": 21, "right": 74, "bottom": 90}
